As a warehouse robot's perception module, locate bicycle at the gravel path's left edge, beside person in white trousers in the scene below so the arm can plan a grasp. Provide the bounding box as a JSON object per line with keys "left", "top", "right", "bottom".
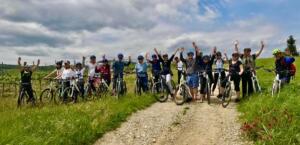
{"left": 152, "top": 75, "right": 174, "bottom": 103}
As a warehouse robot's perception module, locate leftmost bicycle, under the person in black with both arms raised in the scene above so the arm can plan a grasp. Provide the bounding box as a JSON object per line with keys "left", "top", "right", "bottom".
{"left": 17, "top": 83, "right": 36, "bottom": 108}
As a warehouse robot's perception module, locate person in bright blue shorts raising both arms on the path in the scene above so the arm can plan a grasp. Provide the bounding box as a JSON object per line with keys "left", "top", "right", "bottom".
{"left": 180, "top": 48, "right": 199, "bottom": 101}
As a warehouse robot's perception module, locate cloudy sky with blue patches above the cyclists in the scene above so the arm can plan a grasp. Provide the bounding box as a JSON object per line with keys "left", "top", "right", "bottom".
{"left": 0, "top": 0, "right": 300, "bottom": 64}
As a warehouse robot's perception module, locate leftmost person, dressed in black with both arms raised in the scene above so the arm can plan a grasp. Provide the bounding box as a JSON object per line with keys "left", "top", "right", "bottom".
{"left": 18, "top": 57, "right": 40, "bottom": 105}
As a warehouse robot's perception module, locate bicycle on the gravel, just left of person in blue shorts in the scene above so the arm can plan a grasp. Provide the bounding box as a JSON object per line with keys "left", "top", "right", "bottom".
{"left": 174, "top": 71, "right": 192, "bottom": 105}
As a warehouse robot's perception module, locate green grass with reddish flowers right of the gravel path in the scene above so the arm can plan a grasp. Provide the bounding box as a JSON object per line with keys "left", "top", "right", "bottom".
{"left": 238, "top": 58, "right": 300, "bottom": 145}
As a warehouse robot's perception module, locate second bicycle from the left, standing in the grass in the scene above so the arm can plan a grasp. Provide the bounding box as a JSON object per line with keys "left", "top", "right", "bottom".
{"left": 40, "top": 79, "right": 62, "bottom": 104}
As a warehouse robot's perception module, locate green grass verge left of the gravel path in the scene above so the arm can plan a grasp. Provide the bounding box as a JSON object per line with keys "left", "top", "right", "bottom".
{"left": 0, "top": 67, "right": 156, "bottom": 145}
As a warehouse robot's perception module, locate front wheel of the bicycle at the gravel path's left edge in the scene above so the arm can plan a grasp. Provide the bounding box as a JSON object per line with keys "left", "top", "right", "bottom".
{"left": 152, "top": 82, "right": 169, "bottom": 102}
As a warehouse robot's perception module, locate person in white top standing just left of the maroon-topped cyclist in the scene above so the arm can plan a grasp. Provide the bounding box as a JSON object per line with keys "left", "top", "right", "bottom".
{"left": 86, "top": 55, "right": 97, "bottom": 94}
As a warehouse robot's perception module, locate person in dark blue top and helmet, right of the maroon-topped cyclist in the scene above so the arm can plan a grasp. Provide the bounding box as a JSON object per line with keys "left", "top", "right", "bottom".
{"left": 112, "top": 53, "right": 131, "bottom": 94}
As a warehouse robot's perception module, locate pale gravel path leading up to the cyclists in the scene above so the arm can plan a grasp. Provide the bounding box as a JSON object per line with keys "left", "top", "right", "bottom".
{"left": 95, "top": 95, "right": 250, "bottom": 145}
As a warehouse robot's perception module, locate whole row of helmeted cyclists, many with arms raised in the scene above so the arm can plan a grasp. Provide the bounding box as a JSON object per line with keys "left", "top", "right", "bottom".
{"left": 18, "top": 41, "right": 295, "bottom": 102}
